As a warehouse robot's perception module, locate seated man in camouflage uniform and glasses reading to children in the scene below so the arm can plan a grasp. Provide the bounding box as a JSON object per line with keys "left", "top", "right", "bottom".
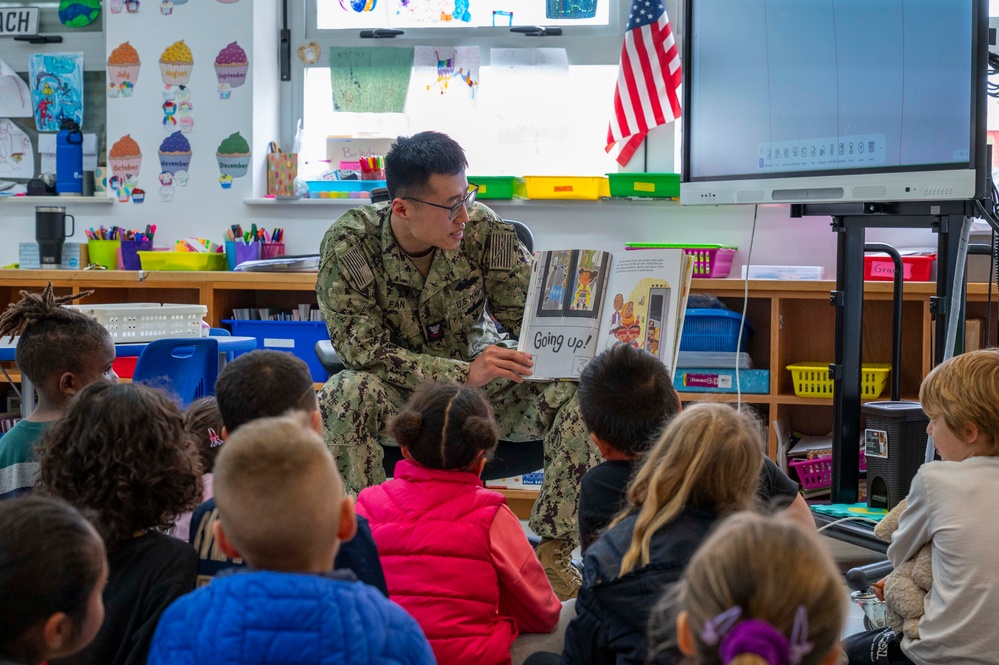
{"left": 316, "top": 132, "right": 598, "bottom": 600}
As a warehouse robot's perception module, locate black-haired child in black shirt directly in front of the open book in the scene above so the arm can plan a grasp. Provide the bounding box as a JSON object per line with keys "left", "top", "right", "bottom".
{"left": 578, "top": 344, "right": 814, "bottom": 554}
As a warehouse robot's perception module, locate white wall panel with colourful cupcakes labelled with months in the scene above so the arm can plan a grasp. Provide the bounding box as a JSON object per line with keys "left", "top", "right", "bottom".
{"left": 104, "top": 0, "right": 254, "bottom": 206}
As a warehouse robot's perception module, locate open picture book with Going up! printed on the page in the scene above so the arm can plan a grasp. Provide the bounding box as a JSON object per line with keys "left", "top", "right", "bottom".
{"left": 517, "top": 249, "right": 693, "bottom": 381}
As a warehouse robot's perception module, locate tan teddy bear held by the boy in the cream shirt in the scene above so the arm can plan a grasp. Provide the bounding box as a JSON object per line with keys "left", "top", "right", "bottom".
{"left": 874, "top": 499, "right": 933, "bottom": 640}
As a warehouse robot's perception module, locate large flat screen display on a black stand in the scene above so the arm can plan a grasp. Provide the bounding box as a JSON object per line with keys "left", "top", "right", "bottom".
{"left": 680, "top": 0, "right": 988, "bottom": 204}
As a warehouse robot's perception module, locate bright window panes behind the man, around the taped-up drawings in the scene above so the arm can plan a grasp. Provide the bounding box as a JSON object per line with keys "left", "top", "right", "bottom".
{"left": 287, "top": 0, "right": 629, "bottom": 177}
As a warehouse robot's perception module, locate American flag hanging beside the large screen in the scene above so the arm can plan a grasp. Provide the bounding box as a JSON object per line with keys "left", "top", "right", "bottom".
{"left": 606, "top": 0, "right": 682, "bottom": 166}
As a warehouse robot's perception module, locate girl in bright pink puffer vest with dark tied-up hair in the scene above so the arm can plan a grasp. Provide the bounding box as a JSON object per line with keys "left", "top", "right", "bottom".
{"left": 357, "top": 383, "right": 562, "bottom": 665}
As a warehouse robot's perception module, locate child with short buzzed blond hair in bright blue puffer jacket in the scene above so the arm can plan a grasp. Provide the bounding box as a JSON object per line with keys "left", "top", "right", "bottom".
{"left": 148, "top": 412, "right": 434, "bottom": 665}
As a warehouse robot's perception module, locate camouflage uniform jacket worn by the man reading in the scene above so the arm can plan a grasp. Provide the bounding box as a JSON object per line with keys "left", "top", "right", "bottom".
{"left": 316, "top": 203, "right": 531, "bottom": 390}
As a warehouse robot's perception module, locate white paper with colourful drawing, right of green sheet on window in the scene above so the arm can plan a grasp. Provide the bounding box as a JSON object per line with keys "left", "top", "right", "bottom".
{"left": 407, "top": 46, "right": 480, "bottom": 112}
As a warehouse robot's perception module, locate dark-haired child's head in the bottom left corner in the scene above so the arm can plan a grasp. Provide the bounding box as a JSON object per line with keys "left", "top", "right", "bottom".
{"left": 0, "top": 496, "right": 108, "bottom": 665}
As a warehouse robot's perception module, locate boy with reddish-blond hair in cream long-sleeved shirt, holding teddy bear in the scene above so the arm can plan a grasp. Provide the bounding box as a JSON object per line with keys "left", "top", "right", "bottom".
{"left": 844, "top": 349, "right": 999, "bottom": 665}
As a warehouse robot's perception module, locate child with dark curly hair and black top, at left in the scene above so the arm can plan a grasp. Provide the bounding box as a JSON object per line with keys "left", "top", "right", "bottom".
{"left": 39, "top": 383, "right": 201, "bottom": 665}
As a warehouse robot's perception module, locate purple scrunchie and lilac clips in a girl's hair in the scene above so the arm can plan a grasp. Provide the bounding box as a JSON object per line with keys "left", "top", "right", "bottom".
{"left": 701, "top": 605, "right": 812, "bottom": 665}
